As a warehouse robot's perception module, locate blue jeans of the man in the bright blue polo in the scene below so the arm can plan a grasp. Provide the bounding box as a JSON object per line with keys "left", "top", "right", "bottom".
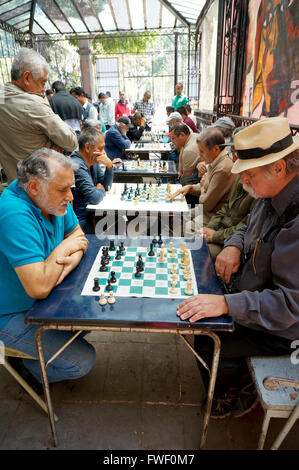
{"left": 0, "top": 312, "right": 96, "bottom": 383}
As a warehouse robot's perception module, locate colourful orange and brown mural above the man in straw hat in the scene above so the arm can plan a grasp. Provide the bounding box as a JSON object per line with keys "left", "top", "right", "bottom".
{"left": 240, "top": 0, "right": 299, "bottom": 124}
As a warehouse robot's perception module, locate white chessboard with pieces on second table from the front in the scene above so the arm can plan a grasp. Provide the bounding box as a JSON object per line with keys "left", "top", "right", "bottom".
{"left": 87, "top": 183, "right": 189, "bottom": 213}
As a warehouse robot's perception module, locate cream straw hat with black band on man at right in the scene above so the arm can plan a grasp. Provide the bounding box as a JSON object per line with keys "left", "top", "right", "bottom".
{"left": 232, "top": 117, "right": 299, "bottom": 173}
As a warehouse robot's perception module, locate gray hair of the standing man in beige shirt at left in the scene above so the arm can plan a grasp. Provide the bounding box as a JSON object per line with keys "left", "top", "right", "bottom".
{"left": 10, "top": 47, "right": 49, "bottom": 81}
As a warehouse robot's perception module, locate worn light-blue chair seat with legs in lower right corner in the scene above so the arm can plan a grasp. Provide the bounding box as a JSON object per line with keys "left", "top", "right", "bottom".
{"left": 248, "top": 356, "right": 299, "bottom": 450}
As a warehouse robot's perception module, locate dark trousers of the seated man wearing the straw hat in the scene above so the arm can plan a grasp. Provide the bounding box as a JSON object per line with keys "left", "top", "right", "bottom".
{"left": 194, "top": 323, "right": 293, "bottom": 396}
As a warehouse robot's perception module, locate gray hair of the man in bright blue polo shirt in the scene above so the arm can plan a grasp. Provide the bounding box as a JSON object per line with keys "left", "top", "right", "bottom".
{"left": 17, "top": 147, "right": 78, "bottom": 192}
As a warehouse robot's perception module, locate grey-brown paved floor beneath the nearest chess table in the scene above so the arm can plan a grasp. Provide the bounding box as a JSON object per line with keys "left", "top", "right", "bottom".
{"left": 0, "top": 332, "right": 299, "bottom": 450}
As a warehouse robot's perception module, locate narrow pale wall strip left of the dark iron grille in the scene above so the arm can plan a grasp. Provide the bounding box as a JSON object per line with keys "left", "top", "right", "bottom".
{"left": 199, "top": 0, "right": 219, "bottom": 111}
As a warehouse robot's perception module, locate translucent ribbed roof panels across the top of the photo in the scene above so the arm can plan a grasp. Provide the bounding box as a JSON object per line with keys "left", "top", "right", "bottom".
{"left": 0, "top": 0, "right": 206, "bottom": 35}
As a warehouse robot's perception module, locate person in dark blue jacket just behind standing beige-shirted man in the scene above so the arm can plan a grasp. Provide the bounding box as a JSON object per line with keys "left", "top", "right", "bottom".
{"left": 49, "top": 81, "right": 83, "bottom": 133}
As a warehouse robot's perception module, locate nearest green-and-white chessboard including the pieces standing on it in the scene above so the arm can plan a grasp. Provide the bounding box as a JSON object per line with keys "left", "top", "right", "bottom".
{"left": 81, "top": 238, "right": 198, "bottom": 301}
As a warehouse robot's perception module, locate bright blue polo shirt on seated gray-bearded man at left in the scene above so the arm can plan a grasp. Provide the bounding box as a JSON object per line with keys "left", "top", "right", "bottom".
{"left": 0, "top": 180, "right": 78, "bottom": 329}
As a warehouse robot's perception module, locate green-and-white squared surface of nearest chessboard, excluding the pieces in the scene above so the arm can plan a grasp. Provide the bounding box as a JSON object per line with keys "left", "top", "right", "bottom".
{"left": 81, "top": 247, "right": 198, "bottom": 299}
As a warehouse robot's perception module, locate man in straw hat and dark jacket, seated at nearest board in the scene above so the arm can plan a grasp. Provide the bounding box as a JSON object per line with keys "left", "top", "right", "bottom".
{"left": 178, "top": 117, "right": 299, "bottom": 418}
